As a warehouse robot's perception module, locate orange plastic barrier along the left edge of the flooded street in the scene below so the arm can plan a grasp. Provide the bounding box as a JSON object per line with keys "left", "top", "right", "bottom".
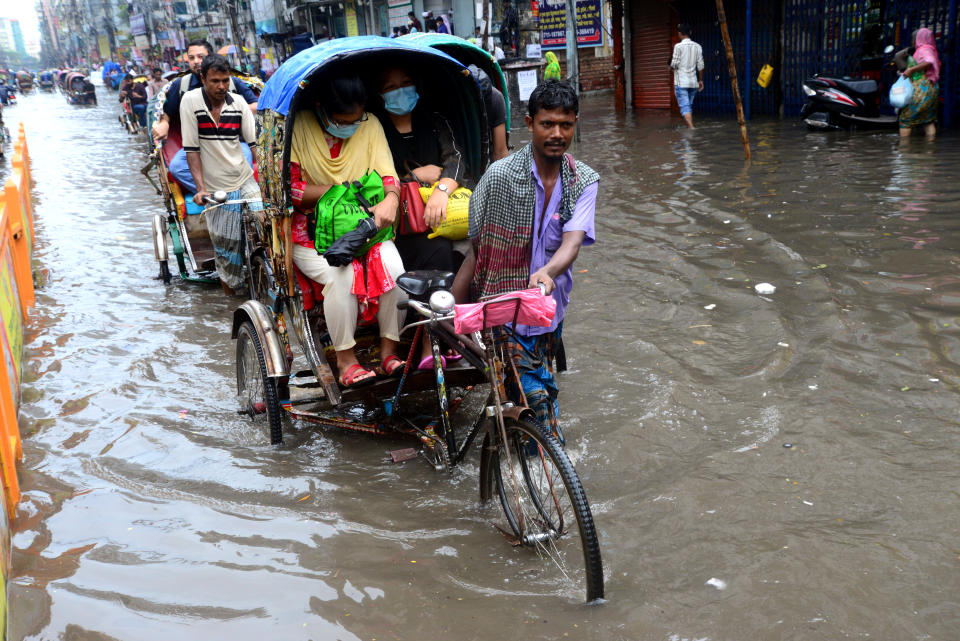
{"left": 0, "top": 124, "right": 35, "bottom": 518}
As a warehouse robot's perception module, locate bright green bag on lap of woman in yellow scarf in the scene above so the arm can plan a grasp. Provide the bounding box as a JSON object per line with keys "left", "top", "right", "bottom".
{"left": 314, "top": 171, "right": 393, "bottom": 256}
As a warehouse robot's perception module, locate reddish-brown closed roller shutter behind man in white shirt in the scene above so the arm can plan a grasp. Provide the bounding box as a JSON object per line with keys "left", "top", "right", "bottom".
{"left": 630, "top": 0, "right": 673, "bottom": 109}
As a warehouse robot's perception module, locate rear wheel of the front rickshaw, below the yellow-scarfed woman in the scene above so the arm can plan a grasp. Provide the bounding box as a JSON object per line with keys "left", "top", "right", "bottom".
{"left": 237, "top": 321, "right": 283, "bottom": 445}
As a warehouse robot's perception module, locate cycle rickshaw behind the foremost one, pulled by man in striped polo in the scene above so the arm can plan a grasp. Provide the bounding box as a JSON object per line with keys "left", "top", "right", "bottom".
{"left": 146, "top": 70, "right": 263, "bottom": 285}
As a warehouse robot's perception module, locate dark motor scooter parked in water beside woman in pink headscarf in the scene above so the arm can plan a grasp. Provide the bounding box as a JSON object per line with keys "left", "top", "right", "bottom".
{"left": 800, "top": 47, "right": 898, "bottom": 130}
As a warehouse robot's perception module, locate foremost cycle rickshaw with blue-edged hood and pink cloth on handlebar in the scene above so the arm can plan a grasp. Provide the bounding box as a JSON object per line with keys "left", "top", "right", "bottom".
{"left": 232, "top": 36, "right": 604, "bottom": 602}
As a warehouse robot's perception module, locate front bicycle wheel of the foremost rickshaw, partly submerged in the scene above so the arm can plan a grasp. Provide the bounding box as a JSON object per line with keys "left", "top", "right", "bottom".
{"left": 481, "top": 416, "right": 603, "bottom": 601}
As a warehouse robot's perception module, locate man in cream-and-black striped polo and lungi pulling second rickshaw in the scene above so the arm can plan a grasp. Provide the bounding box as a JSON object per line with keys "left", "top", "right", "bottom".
{"left": 180, "top": 54, "right": 263, "bottom": 294}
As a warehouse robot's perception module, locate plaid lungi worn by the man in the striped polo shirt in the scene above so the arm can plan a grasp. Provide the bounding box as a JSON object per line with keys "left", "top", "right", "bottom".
{"left": 204, "top": 178, "right": 263, "bottom": 289}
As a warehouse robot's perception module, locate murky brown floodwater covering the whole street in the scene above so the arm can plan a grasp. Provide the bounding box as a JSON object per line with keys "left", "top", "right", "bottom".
{"left": 1, "top": 87, "right": 960, "bottom": 641}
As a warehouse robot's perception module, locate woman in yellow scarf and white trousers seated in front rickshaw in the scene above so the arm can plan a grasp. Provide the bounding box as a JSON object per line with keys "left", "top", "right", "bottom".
{"left": 284, "top": 76, "right": 406, "bottom": 387}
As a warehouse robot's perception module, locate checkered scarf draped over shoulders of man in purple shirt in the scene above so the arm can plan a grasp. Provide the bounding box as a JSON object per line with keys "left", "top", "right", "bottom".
{"left": 470, "top": 144, "right": 600, "bottom": 298}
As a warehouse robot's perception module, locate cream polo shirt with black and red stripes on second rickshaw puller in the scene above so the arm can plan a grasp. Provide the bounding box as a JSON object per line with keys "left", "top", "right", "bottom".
{"left": 180, "top": 87, "right": 256, "bottom": 192}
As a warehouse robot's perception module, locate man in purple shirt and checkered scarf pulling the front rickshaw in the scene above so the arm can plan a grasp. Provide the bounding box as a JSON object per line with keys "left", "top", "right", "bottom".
{"left": 454, "top": 80, "right": 600, "bottom": 441}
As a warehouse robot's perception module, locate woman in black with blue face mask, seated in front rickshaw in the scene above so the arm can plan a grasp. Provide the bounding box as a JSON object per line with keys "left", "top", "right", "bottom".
{"left": 379, "top": 67, "right": 472, "bottom": 369}
